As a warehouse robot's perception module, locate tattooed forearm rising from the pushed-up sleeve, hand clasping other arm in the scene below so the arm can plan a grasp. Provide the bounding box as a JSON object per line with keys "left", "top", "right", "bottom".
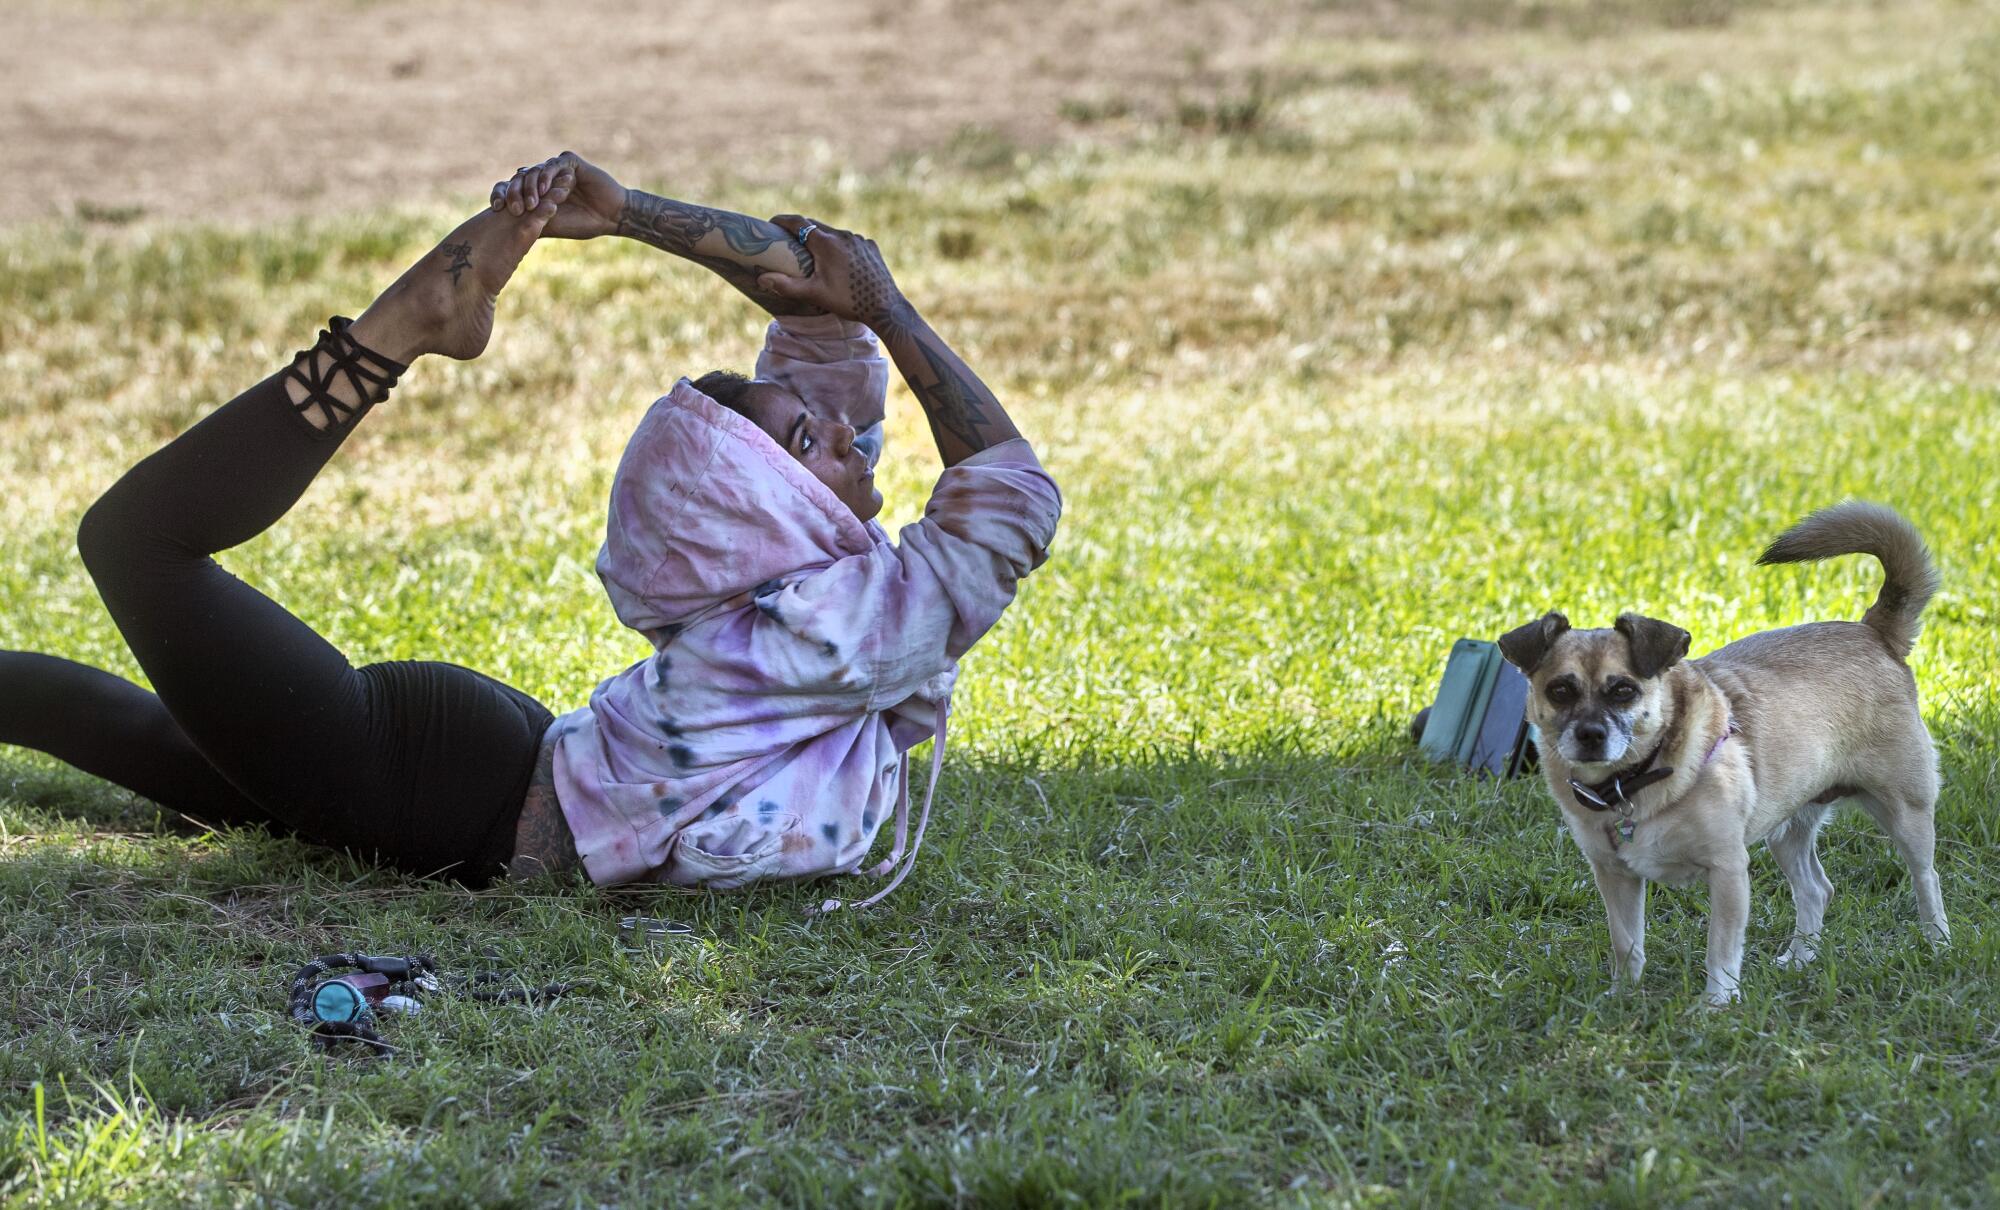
{"left": 758, "top": 214, "right": 1020, "bottom": 466}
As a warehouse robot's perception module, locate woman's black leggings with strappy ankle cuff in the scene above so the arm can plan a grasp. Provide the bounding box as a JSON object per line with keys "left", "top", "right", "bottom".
{"left": 0, "top": 326, "right": 552, "bottom": 884}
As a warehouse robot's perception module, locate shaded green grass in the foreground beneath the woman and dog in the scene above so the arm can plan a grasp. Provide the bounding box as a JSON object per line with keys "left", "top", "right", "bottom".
{"left": 0, "top": 700, "right": 2000, "bottom": 1202}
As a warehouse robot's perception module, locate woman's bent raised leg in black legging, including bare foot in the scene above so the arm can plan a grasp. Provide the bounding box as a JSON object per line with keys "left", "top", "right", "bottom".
{"left": 78, "top": 194, "right": 562, "bottom": 862}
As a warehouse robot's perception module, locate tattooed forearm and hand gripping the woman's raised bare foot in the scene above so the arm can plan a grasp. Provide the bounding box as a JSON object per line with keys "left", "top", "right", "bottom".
{"left": 492, "top": 152, "right": 820, "bottom": 316}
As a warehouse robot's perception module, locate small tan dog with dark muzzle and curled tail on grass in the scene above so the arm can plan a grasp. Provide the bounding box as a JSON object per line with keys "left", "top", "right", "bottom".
{"left": 1500, "top": 502, "right": 1950, "bottom": 1006}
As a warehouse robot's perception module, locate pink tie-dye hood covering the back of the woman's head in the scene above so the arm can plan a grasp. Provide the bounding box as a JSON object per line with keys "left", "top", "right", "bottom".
{"left": 598, "top": 378, "right": 874, "bottom": 648}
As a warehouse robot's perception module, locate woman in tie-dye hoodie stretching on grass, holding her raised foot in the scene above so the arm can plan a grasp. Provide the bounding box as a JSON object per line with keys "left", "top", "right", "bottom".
{"left": 0, "top": 154, "right": 1060, "bottom": 894}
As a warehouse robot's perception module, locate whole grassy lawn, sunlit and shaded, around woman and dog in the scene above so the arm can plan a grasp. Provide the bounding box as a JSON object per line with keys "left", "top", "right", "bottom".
{"left": 0, "top": 2, "right": 2000, "bottom": 1206}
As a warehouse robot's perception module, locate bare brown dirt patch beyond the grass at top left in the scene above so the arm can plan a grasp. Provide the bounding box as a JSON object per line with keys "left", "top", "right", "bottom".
{"left": 11, "top": 0, "right": 1312, "bottom": 222}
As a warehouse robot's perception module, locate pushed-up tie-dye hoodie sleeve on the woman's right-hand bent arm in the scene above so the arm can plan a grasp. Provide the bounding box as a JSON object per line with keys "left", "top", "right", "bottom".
{"left": 758, "top": 440, "right": 1062, "bottom": 710}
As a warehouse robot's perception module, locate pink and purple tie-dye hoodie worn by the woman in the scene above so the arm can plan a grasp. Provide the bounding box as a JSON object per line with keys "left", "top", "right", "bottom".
{"left": 552, "top": 316, "right": 1062, "bottom": 886}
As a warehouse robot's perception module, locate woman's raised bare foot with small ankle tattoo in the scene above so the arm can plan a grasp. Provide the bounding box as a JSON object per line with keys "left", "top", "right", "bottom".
{"left": 350, "top": 176, "right": 574, "bottom": 362}
